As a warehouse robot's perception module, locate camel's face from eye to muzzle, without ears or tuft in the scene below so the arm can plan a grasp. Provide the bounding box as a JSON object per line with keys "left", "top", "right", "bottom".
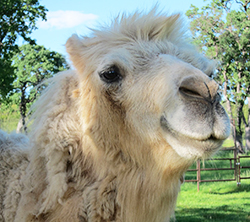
{"left": 95, "top": 50, "right": 230, "bottom": 158}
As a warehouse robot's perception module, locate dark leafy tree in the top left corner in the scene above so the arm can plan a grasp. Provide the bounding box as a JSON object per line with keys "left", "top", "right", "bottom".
{"left": 0, "top": 0, "right": 47, "bottom": 102}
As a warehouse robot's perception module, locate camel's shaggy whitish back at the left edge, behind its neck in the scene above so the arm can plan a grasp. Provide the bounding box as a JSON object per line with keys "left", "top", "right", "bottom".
{"left": 0, "top": 130, "right": 29, "bottom": 221}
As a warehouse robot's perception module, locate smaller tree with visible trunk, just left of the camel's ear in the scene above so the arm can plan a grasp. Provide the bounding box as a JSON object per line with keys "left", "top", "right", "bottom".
{"left": 10, "top": 44, "right": 68, "bottom": 132}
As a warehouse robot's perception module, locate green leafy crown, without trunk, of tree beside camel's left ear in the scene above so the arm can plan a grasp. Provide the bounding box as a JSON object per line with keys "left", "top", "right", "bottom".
{"left": 12, "top": 44, "right": 67, "bottom": 94}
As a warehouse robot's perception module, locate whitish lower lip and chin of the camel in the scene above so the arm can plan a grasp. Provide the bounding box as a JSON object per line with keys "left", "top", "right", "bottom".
{"left": 161, "top": 116, "right": 224, "bottom": 159}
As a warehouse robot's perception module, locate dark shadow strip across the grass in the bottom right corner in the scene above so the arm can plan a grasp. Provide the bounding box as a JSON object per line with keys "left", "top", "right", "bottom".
{"left": 175, "top": 204, "right": 250, "bottom": 222}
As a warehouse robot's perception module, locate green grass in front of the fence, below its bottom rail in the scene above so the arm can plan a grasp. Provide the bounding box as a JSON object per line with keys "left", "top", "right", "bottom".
{"left": 175, "top": 180, "right": 250, "bottom": 222}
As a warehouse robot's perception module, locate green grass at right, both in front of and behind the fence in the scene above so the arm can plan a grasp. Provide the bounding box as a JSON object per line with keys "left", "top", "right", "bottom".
{"left": 175, "top": 147, "right": 250, "bottom": 222}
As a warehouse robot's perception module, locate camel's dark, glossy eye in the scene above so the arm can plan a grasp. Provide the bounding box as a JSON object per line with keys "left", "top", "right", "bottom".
{"left": 99, "top": 66, "right": 122, "bottom": 83}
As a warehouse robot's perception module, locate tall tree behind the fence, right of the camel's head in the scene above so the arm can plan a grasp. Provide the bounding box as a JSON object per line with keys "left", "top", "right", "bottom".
{"left": 186, "top": 0, "right": 250, "bottom": 151}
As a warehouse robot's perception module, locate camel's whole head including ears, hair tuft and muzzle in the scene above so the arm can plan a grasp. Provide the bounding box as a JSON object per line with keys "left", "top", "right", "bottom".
{"left": 66, "top": 10, "right": 230, "bottom": 159}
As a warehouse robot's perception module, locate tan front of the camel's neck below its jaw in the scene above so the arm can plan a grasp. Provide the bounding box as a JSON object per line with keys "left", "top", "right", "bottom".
{"left": 82, "top": 139, "right": 188, "bottom": 222}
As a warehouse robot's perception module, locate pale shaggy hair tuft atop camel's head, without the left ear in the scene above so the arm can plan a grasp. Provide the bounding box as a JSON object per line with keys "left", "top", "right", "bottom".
{"left": 92, "top": 5, "right": 186, "bottom": 43}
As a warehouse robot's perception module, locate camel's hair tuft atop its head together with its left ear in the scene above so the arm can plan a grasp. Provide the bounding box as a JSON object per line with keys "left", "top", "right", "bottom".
{"left": 66, "top": 5, "right": 189, "bottom": 73}
